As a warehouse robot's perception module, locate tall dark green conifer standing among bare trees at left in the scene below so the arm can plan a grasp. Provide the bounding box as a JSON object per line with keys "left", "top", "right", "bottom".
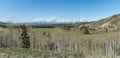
{"left": 21, "top": 24, "right": 30, "bottom": 48}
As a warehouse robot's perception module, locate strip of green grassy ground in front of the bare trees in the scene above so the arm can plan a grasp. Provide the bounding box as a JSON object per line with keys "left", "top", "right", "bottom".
{"left": 0, "top": 48, "right": 75, "bottom": 58}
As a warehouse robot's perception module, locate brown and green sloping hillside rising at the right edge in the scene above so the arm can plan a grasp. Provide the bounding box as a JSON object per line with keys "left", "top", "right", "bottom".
{"left": 90, "top": 14, "right": 120, "bottom": 31}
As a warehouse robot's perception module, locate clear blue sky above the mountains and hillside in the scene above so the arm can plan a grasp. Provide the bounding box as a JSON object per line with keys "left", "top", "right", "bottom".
{"left": 0, "top": 0, "right": 120, "bottom": 22}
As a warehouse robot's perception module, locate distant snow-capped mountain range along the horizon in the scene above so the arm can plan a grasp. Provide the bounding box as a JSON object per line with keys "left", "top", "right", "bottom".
{"left": 28, "top": 17, "right": 85, "bottom": 24}
